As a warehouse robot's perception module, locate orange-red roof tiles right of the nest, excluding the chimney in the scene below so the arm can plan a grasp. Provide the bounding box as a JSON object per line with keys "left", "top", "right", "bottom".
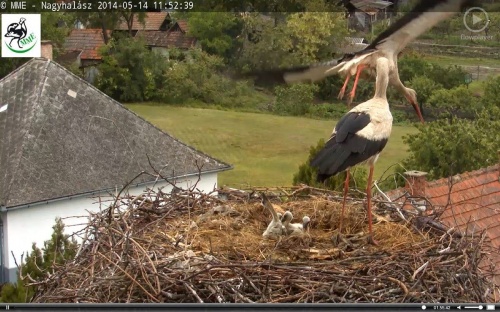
{"left": 387, "top": 164, "right": 500, "bottom": 285}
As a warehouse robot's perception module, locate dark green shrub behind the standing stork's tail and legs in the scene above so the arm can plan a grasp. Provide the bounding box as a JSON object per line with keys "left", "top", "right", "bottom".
{"left": 293, "top": 139, "right": 368, "bottom": 191}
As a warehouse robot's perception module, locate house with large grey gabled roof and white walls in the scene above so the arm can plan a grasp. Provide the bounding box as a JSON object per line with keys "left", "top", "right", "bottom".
{"left": 0, "top": 58, "right": 231, "bottom": 281}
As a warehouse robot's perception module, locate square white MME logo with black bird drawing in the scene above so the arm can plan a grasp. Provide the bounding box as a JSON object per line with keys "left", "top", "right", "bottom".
{"left": 1, "top": 14, "right": 41, "bottom": 57}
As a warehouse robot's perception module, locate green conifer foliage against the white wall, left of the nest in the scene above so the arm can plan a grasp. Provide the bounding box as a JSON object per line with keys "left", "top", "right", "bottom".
{"left": 0, "top": 218, "right": 78, "bottom": 303}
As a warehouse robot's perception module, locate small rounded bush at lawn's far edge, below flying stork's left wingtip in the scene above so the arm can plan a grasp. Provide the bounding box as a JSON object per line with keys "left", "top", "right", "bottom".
{"left": 273, "top": 84, "right": 318, "bottom": 116}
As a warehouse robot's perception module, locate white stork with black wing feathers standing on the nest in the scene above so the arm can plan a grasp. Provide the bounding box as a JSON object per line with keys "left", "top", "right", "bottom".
{"left": 311, "top": 57, "right": 393, "bottom": 243}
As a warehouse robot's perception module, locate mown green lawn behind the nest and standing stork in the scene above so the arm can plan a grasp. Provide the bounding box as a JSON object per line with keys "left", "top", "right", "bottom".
{"left": 127, "top": 104, "right": 417, "bottom": 187}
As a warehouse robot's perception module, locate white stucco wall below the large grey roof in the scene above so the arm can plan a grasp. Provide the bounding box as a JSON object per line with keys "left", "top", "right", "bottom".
{"left": 4, "top": 173, "right": 217, "bottom": 281}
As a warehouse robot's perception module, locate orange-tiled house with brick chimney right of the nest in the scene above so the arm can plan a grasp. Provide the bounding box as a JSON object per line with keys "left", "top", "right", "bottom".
{"left": 387, "top": 153, "right": 500, "bottom": 296}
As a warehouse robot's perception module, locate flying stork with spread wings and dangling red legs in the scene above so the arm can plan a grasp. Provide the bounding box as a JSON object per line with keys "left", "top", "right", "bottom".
{"left": 248, "top": 0, "right": 473, "bottom": 122}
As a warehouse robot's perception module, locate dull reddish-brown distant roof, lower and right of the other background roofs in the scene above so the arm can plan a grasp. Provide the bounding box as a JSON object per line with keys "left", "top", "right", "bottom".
{"left": 136, "top": 30, "right": 196, "bottom": 49}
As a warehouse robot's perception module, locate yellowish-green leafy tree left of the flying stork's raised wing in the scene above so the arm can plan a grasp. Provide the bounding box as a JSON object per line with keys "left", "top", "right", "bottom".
{"left": 239, "top": 10, "right": 348, "bottom": 71}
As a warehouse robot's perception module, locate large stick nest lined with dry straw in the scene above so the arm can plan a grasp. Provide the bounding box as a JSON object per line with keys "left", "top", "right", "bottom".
{"left": 29, "top": 188, "right": 492, "bottom": 303}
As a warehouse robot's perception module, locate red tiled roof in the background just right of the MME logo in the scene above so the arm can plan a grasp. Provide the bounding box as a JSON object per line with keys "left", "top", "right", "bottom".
{"left": 64, "top": 29, "right": 111, "bottom": 60}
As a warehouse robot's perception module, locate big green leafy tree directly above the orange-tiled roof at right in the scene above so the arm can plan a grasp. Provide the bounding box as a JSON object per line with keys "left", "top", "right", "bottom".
{"left": 403, "top": 107, "right": 500, "bottom": 179}
